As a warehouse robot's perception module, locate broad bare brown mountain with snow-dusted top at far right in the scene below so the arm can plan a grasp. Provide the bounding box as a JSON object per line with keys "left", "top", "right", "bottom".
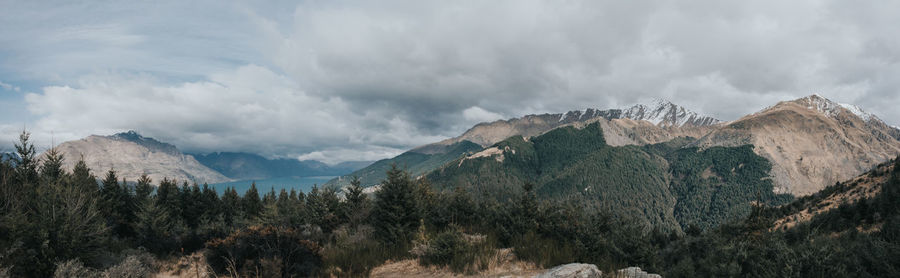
{"left": 695, "top": 95, "right": 900, "bottom": 196}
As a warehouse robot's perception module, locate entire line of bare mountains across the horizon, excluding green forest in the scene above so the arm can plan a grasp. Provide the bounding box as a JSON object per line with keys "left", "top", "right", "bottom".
{"left": 45, "top": 95, "right": 900, "bottom": 205}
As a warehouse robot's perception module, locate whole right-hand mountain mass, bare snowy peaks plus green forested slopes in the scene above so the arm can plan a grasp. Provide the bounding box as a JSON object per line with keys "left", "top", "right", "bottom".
{"left": 331, "top": 95, "right": 900, "bottom": 231}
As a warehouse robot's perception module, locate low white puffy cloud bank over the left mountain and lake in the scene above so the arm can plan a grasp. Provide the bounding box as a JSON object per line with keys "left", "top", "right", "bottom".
{"left": 19, "top": 65, "right": 441, "bottom": 162}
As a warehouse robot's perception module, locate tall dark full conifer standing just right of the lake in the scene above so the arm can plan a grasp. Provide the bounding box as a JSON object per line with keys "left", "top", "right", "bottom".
{"left": 372, "top": 164, "right": 420, "bottom": 244}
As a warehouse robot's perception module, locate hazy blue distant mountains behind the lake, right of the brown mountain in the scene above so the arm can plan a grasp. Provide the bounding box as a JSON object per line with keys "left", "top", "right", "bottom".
{"left": 193, "top": 152, "right": 371, "bottom": 180}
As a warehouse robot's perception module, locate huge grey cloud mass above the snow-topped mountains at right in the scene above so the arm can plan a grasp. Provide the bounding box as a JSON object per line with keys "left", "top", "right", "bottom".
{"left": 251, "top": 1, "right": 900, "bottom": 124}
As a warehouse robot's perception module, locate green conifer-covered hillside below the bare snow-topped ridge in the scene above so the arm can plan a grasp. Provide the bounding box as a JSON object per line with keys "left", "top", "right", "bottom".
{"left": 427, "top": 123, "right": 792, "bottom": 231}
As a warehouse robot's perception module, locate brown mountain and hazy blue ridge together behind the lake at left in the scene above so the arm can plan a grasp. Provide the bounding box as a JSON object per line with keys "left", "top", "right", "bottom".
{"left": 47, "top": 131, "right": 370, "bottom": 184}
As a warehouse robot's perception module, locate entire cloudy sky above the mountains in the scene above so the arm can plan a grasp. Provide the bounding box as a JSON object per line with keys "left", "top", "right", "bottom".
{"left": 0, "top": 0, "right": 900, "bottom": 163}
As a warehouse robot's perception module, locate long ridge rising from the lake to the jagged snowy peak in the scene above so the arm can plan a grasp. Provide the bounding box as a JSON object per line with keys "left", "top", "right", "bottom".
{"left": 329, "top": 100, "right": 721, "bottom": 186}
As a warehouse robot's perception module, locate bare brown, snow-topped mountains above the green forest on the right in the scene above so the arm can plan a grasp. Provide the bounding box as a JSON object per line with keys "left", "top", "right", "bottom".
{"left": 329, "top": 95, "right": 900, "bottom": 199}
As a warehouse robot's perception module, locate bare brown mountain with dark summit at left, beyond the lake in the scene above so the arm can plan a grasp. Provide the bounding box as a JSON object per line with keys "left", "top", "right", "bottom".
{"left": 48, "top": 131, "right": 231, "bottom": 186}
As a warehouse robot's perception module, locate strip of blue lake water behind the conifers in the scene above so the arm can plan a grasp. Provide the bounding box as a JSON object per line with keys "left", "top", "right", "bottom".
{"left": 209, "top": 176, "right": 334, "bottom": 197}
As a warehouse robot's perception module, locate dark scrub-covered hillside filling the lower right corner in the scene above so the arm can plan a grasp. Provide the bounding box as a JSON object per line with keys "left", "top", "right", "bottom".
{"left": 661, "top": 159, "right": 900, "bottom": 277}
